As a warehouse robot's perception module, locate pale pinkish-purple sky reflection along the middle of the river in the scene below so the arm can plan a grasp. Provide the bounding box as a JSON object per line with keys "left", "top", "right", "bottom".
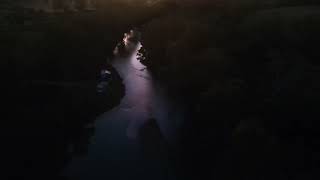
{"left": 113, "top": 44, "right": 154, "bottom": 138}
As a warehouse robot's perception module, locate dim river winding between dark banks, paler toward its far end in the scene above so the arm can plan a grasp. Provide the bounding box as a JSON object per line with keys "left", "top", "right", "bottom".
{"left": 64, "top": 41, "right": 184, "bottom": 180}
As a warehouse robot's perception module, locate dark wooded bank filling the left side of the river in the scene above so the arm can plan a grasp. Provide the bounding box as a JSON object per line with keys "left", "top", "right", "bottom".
{"left": 0, "top": 3, "right": 174, "bottom": 179}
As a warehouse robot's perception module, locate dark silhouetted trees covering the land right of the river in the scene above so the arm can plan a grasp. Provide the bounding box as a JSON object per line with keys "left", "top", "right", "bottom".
{"left": 143, "top": 0, "right": 320, "bottom": 180}
